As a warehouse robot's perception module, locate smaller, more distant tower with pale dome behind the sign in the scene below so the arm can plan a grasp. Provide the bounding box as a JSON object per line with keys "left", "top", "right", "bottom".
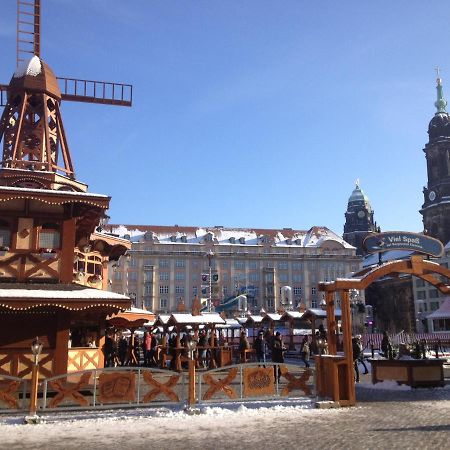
{"left": 342, "top": 180, "right": 377, "bottom": 255}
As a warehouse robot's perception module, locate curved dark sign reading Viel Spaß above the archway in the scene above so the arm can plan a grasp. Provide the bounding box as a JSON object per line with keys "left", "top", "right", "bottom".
{"left": 363, "top": 231, "right": 444, "bottom": 257}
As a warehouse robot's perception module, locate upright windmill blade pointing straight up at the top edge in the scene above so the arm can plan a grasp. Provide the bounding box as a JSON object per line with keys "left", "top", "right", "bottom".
{"left": 16, "top": 0, "right": 41, "bottom": 66}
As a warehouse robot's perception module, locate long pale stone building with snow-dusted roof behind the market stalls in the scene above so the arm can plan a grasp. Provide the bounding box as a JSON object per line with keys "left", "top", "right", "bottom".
{"left": 107, "top": 225, "right": 361, "bottom": 313}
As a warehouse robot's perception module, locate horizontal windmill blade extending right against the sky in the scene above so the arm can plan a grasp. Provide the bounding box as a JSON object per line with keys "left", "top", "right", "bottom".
{"left": 57, "top": 77, "right": 133, "bottom": 106}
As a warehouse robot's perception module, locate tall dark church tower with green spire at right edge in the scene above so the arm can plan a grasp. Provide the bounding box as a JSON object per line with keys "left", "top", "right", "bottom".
{"left": 420, "top": 73, "right": 450, "bottom": 245}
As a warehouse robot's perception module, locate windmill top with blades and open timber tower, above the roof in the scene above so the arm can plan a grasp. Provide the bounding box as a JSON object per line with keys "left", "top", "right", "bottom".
{"left": 0, "top": 0, "right": 132, "bottom": 180}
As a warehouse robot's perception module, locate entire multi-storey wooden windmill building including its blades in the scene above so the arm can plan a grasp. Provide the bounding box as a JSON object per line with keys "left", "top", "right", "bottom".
{"left": 0, "top": 0, "right": 131, "bottom": 377}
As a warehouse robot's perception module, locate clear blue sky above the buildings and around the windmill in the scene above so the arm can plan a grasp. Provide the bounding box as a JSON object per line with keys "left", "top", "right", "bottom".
{"left": 0, "top": 0, "right": 450, "bottom": 234}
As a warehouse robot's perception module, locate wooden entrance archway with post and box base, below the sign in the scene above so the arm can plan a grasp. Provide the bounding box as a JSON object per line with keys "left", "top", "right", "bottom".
{"left": 316, "top": 256, "right": 450, "bottom": 406}
